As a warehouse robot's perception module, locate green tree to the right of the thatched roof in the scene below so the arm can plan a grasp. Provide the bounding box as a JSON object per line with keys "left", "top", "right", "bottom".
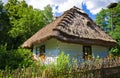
{"left": 96, "top": 2, "right": 120, "bottom": 33}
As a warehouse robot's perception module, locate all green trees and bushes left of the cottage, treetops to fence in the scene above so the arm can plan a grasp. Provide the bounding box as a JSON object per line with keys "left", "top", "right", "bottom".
{"left": 0, "top": 0, "right": 53, "bottom": 69}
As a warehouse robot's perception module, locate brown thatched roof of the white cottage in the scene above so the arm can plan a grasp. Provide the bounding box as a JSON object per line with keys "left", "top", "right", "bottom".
{"left": 22, "top": 7, "right": 116, "bottom": 48}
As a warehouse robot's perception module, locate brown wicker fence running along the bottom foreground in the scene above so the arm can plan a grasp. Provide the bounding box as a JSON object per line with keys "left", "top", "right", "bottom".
{"left": 0, "top": 58, "right": 120, "bottom": 78}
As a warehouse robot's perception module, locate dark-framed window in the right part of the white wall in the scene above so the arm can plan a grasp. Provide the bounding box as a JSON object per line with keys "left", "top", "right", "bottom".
{"left": 83, "top": 46, "right": 92, "bottom": 60}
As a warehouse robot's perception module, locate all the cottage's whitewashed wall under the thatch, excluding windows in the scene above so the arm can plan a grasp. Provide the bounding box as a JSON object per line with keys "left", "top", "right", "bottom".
{"left": 33, "top": 39, "right": 108, "bottom": 62}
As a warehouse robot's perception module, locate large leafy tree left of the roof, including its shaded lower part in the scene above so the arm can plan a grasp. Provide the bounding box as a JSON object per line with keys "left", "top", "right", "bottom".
{"left": 5, "top": 0, "right": 52, "bottom": 49}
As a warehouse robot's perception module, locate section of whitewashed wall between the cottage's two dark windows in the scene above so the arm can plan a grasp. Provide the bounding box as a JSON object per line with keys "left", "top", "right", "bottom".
{"left": 46, "top": 39, "right": 82, "bottom": 58}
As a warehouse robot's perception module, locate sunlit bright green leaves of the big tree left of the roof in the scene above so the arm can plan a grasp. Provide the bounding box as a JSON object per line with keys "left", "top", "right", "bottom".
{"left": 6, "top": 1, "right": 52, "bottom": 38}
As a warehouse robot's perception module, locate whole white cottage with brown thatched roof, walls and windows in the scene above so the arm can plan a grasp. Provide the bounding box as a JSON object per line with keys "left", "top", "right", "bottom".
{"left": 22, "top": 7, "right": 116, "bottom": 59}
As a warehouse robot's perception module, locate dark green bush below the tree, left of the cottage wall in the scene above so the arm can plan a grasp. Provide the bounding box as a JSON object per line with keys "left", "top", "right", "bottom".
{"left": 0, "top": 46, "right": 33, "bottom": 69}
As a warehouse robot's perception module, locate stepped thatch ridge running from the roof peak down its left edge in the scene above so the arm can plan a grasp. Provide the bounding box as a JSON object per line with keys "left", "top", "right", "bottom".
{"left": 55, "top": 6, "right": 88, "bottom": 30}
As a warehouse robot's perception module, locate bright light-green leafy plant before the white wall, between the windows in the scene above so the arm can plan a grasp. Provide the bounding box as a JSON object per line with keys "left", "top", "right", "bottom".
{"left": 49, "top": 52, "right": 71, "bottom": 74}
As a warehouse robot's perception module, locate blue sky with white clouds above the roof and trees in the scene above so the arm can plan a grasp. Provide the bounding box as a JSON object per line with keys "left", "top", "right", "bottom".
{"left": 2, "top": 0, "right": 118, "bottom": 20}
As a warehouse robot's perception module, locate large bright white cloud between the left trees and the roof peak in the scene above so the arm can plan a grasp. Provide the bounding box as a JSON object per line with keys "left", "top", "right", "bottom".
{"left": 27, "top": 0, "right": 83, "bottom": 14}
